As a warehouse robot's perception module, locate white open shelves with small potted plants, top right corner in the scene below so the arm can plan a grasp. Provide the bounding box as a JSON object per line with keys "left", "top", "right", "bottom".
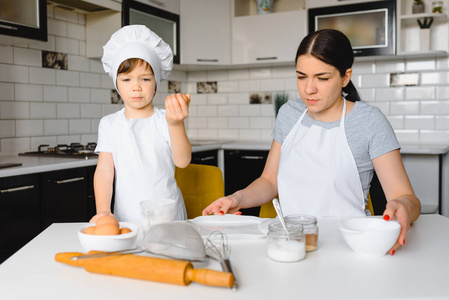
{"left": 397, "top": 0, "right": 449, "bottom": 57}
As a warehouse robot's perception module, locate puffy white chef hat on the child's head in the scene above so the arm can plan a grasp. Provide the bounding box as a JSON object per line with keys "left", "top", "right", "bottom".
{"left": 101, "top": 25, "right": 173, "bottom": 91}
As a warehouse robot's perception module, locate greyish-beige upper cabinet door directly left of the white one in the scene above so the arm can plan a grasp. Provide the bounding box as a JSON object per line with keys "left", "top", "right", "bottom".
{"left": 180, "top": 0, "right": 231, "bottom": 65}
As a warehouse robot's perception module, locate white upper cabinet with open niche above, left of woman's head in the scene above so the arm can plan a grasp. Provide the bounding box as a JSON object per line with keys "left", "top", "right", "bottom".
{"left": 231, "top": 0, "right": 307, "bottom": 65}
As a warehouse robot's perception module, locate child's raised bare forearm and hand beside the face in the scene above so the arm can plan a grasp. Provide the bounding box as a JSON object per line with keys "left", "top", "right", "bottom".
{"left": 165, "top": 94, "right": 192, "bottom": 168}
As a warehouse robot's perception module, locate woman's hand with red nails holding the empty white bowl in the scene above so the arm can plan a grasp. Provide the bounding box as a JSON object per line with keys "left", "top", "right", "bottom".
{"left": 383, "top": 199, "right": 410, "bottom": 255}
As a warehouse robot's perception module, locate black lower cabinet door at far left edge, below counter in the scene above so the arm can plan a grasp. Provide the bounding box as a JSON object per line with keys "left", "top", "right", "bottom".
{"left": 0, "top": 174, "right": 41, "bottom": 263}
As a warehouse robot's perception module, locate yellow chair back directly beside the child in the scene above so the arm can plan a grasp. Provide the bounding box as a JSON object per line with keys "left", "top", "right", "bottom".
{"left": 175, "top": 164, "right": 224, "bottom": 219}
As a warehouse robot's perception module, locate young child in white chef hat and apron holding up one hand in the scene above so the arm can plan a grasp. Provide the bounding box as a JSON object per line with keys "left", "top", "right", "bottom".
{"left": 91, "top": 25, "right": 191, "bottom": 223}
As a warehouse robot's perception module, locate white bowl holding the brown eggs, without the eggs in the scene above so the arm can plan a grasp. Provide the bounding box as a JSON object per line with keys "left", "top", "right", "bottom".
{"left": 78, "top": 222, "right": 139, "bottom": 252}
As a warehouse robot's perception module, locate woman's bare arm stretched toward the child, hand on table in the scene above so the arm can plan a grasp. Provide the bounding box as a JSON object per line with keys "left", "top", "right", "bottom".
{"left": 203, "top": 140, "right": 281, "bottom": 216}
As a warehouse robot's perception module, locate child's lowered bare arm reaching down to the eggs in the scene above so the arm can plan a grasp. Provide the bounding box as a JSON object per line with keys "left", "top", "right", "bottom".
{"left": 90, "top": 152, "right": 114, "bottom": 223}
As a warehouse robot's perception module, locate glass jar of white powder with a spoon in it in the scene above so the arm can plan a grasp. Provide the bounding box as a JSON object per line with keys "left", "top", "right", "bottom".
{"left": 267, "top": 220, "right": 306, "bottom": 262}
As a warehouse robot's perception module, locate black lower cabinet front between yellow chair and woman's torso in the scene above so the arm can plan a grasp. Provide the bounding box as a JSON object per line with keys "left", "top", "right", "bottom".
{"left": 224, "top": 150, "right": 268, "bottom": 216}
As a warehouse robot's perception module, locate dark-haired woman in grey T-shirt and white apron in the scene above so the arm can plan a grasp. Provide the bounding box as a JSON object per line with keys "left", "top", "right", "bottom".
{"left": 203, "top": 29, "right": 421, "bottom": 255}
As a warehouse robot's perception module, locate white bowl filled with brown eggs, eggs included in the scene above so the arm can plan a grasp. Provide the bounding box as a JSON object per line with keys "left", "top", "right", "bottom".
{"left": 78, "top": 216, "right": 139, "bottom": 252}
